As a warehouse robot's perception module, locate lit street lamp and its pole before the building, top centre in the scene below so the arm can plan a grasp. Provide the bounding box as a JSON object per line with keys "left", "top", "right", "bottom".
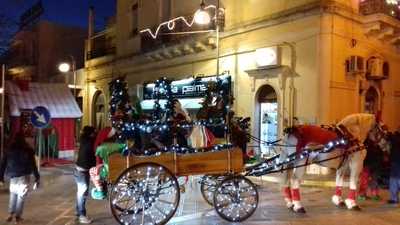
{"left": 194, "top": 0, "right": 219, "bottom": 77}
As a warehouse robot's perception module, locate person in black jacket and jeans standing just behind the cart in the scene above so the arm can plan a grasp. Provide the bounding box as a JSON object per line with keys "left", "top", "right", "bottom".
{"left": 74, "top": 126, "right": 96, "bottom": 224}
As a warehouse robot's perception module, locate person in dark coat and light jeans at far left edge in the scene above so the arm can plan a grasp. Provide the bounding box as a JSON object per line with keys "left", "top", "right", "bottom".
{"left": 0, "top": 132, "right": 40, "bottom": 224}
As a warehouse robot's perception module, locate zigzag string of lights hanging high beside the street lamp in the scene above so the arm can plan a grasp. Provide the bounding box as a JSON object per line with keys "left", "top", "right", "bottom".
{"left": 140, "top": 5, "right": 225, "bottom": 39}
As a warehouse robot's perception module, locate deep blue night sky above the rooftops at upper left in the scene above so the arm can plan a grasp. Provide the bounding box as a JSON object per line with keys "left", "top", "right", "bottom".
{"left": 0, "top": 0, "right": 116, "bottom": 30}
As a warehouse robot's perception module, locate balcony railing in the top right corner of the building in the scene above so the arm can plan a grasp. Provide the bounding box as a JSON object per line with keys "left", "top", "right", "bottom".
{"left": 359, "top": 0, "right": 400, "bottom": 19}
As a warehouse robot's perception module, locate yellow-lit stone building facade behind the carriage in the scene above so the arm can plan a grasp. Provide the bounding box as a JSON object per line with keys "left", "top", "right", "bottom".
{"left": 83, "top": 0, "right": 400, "bottom": 144}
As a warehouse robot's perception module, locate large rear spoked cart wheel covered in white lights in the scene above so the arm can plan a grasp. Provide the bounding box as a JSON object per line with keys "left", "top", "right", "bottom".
{"left": 110, "top": 163, "right": 180, "bottom": 225}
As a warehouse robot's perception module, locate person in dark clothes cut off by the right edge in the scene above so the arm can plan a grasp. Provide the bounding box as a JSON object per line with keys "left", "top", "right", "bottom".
{"left": 388, "top": 128, "right": 400, "bottom": 204}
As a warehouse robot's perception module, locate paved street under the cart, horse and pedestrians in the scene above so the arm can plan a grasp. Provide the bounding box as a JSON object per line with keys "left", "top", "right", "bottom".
{"left": 0, "top": 164, "right": 400, "bottom": 225}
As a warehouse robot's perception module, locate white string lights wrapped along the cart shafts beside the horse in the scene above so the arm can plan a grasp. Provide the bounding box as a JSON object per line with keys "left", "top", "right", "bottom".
{"left": 246, "top": 139, "right": 348, "bottom": 176}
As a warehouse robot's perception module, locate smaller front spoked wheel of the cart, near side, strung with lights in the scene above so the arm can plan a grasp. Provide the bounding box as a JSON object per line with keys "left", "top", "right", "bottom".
{"left": 214, "top": 176, "right": 258, "bottom": 222}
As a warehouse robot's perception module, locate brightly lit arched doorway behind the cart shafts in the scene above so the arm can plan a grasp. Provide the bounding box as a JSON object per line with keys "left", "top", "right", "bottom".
{"left": 257, "top": 85, "right": 278, "bottom": 154}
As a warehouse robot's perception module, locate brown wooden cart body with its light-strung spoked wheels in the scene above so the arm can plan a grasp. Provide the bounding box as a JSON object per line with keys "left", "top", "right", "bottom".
{"left": 109, "top": 148, "right": 258, "bottom": 224}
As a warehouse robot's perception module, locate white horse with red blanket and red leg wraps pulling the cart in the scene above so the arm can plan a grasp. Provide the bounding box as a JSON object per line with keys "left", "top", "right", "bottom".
{"left": 280, "top": 113, "right": 389, "bottom": 213}
